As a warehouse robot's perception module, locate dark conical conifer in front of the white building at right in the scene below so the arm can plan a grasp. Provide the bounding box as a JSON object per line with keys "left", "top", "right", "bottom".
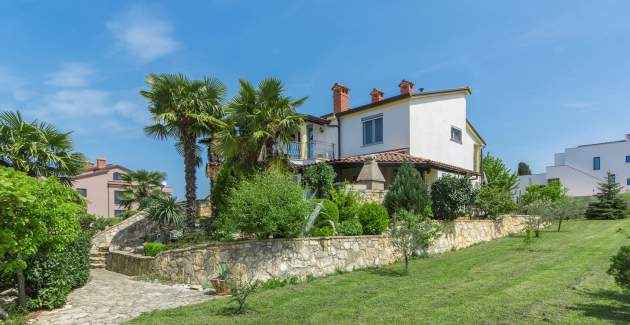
{"left": 586, "top": 172, "right": 627, "bottom": 219}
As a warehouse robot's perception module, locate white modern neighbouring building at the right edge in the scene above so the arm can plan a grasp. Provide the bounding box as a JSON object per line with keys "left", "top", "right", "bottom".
{"left": 517, "top": 135, "right": 630, "bottom": 196}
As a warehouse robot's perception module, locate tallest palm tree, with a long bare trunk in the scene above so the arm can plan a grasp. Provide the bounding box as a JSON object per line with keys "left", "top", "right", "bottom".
{"left": 140, "top": 74, "right": 225, "bottom": 228}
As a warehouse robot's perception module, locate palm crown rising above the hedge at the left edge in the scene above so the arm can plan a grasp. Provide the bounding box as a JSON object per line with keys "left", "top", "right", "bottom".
{"left": 0, "top": 112, "right": 86, "bottom": 185}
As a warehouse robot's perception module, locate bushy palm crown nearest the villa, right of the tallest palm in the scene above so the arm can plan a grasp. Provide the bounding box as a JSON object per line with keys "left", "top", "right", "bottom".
{"left": 215, "top": 78, "right": 308, "bottom": 170}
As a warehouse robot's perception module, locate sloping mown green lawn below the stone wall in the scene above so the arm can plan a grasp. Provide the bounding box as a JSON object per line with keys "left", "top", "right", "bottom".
{"left": 129, "top": 220, "right": 630, "bottom": 325}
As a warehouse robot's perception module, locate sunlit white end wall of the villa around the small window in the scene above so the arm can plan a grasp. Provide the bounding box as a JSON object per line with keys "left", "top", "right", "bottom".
{"left": 409, "top": 94, "right": 475, "bottom": 170}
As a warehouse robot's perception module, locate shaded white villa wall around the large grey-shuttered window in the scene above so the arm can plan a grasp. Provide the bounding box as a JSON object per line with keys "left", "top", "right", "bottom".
{"left": 340, "top": 100, "right": 409, "bottom": 157}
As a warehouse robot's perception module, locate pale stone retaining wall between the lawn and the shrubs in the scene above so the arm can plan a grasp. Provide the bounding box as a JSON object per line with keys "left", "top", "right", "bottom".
{"left": 107, "top": 216, "right": 526, "bottom": 284}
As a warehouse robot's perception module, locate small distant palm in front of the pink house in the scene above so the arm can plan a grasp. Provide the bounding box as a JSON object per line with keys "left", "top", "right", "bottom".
{"left": 120, "top": 169, "right": 165, "bottom": 209}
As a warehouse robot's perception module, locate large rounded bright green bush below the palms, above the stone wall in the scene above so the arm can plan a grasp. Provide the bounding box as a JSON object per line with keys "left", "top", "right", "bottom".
{"left": 219, "top": 173, "right": 311, "bottom": 238}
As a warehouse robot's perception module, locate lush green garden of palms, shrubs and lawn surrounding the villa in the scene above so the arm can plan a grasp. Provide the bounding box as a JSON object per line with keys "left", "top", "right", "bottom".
{"left": 0, "top": 74, "right": 630, "bottom": 323}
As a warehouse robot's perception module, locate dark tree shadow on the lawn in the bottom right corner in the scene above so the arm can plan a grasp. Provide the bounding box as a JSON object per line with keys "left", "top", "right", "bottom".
{"left": 568, "top": 290, "right": 630, "bottom": 323}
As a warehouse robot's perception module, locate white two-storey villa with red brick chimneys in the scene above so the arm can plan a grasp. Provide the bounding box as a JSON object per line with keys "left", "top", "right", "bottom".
{"left": 286, "top": 80, "right": 486, "bottom": 188}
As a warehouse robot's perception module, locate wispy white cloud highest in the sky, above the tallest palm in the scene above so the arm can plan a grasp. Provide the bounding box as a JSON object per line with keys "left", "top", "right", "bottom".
{"left": 107, "top": 8, "right": 179, "bottom": 63}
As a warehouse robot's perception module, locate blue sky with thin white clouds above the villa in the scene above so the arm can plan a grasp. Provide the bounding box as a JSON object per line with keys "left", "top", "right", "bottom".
{"left": 0, "top": 0, "right": 630, "bottom": 198}
